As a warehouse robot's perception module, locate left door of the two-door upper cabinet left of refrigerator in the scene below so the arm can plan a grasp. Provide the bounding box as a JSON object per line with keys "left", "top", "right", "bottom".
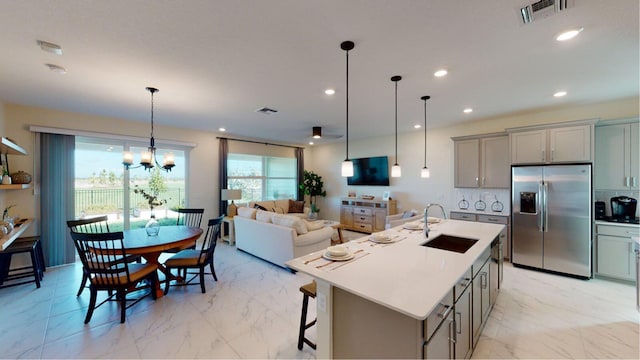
{"left": 454, "top": 139, "right": 480, "bottom": 188}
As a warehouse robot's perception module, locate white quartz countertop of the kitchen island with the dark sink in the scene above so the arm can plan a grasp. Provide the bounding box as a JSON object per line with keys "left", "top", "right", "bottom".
{"left": 287, "top": 220, "right": 504, "bottom": 320}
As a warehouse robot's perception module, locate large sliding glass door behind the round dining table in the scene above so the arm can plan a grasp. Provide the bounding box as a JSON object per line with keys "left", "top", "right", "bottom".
{"left": 75, "top": 136, "right": 187, "bottom": 231}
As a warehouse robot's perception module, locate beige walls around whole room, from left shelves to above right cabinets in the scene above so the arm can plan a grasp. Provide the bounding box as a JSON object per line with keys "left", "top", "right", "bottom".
{"left": 0, "top": 98, "right": 639, "bottom": 235}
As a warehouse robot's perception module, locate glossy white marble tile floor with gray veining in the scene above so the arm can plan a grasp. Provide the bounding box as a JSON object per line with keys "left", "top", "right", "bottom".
{"left": 0, "top": 238, "right": 640, "bottom": 359}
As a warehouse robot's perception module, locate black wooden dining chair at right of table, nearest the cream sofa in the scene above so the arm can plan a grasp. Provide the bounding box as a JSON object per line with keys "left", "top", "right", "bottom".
{"left": 164, "top": 216, "right": 224, "bottom": 295}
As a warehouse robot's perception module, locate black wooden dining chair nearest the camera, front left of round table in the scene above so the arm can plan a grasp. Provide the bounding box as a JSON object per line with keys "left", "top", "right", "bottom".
{"left": 71, "top": 231, "right": 158, "bottom": 324}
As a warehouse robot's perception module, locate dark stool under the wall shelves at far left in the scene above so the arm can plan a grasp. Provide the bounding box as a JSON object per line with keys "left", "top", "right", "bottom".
{"left": 0, "top": 236, "right": 44, "bottom": 288}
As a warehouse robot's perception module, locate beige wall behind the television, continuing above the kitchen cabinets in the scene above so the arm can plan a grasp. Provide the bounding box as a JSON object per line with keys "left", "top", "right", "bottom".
{"left": 305, "top": 98, "right": 639, "bottom": 220}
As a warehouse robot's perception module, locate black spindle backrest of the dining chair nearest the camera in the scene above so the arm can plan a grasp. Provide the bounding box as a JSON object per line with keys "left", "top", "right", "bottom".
{"left": 71, "top": 231, "right": 131, "bottom": 288}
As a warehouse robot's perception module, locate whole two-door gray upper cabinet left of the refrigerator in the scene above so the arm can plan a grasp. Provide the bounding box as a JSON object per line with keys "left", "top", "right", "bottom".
{"left": 452, "top": 134, "right": 510, "bottom": 189}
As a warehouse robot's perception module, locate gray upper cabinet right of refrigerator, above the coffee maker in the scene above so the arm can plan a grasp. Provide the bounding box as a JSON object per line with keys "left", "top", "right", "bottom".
{"left": 594, "top": 120, "right": 640, "bottom": 190}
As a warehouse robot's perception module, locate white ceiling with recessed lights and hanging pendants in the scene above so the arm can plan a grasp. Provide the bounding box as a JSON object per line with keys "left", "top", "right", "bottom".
{"left": 0, "top": 0, "right": 640, "bottom": 144}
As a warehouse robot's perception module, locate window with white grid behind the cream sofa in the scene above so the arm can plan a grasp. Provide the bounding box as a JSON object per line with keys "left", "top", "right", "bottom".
{"left": 227, "top": 153, "right": 298, "bottom": 202}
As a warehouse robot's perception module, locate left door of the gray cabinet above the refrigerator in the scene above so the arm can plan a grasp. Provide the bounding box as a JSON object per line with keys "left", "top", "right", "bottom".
{"left": 509, "top": 130, "right": 547, "bottom": 164}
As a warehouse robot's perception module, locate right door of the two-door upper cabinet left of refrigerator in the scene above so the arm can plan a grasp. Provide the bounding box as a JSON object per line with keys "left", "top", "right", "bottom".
{"left": 480, "top": 135, "right": 511, "bottom": 189}
